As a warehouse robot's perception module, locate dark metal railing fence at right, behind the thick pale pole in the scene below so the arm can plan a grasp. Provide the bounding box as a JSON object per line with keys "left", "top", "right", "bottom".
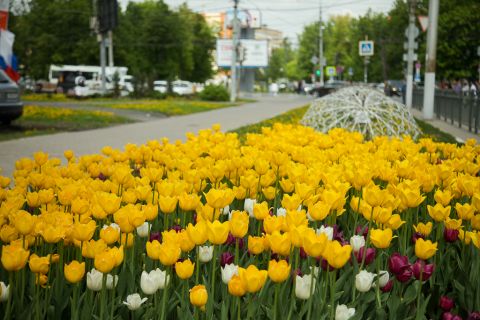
{"left": 412, "top": 89, "right": 480, "bottom": 134}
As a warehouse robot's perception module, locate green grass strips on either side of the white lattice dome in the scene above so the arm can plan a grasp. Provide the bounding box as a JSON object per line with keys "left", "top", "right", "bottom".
{"left": 232, "top": 105, "right": 457, "bottom": 144}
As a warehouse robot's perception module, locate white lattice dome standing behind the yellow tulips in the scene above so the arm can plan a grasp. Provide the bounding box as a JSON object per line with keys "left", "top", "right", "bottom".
{"left": 300, "top": 86, "right": 420, "bottom": 138}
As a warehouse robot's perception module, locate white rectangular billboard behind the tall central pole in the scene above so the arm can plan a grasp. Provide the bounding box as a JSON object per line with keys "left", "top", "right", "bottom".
{"left": 217, "top": 39, "right": 268, "bottom": 68}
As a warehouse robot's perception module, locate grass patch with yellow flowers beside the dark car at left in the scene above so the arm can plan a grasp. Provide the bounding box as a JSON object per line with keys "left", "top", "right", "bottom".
{"left": 0, "top": 105, "right": 131, "bottom": 141}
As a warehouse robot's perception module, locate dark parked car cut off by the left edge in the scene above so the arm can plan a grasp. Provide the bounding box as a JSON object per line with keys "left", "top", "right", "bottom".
{"left": 0, "top": 70, "right": 23, "bottom": 125}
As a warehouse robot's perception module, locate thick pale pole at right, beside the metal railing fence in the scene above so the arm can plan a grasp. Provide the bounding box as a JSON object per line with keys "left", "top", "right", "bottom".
{"left": 423, "top": 0, "right": 439, "bottom": 120}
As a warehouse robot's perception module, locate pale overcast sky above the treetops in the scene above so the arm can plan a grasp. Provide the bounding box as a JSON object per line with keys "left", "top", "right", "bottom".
{"left": 119, "top": 0, "right": 395, "bottom": 43}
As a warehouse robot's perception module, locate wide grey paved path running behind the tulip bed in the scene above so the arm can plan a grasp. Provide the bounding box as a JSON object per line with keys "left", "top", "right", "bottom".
{"left": 0, "top": 95, "right": 313, "bottom": 176}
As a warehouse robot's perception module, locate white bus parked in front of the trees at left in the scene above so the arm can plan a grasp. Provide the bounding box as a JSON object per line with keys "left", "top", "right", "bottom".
{"left": 48, "top": 65, "right": 133, "bottom": 96}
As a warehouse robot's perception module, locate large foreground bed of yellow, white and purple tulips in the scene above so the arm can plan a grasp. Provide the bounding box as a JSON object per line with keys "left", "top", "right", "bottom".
{"left": 0, "top": 124, "right": 480, "bottom": 319}
